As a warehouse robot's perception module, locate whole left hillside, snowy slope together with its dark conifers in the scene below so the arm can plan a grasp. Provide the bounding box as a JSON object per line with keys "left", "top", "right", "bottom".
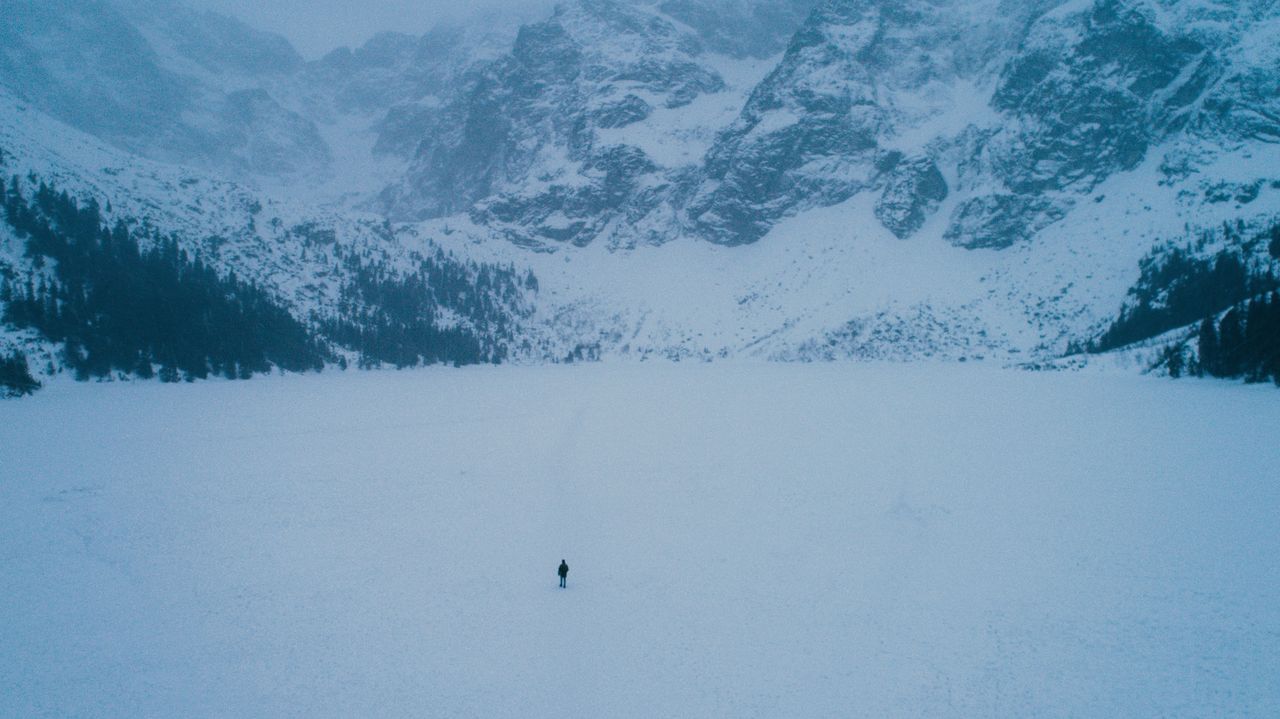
{"left": 0, "top": 86, "right": 553, "bottom": 379}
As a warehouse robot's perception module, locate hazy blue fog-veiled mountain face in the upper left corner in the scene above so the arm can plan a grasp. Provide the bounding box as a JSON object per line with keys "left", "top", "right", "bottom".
{"left": 0, "top": 0, "right": 329, "bottom": 177}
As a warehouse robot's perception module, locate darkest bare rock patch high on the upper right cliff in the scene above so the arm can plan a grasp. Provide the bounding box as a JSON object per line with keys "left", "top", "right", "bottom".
{"left": 992, "top": 0, "right": 1219, "bottom": 194}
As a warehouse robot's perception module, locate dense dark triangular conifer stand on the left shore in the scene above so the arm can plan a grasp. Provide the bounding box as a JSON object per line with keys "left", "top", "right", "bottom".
{"left": 0, "top": 178, "right": 328, "bottom": 381}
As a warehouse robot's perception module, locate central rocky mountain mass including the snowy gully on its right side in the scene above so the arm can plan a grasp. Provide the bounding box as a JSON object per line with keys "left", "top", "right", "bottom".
{"left": 381, "top": 0, "right": 799, "bottom": 247}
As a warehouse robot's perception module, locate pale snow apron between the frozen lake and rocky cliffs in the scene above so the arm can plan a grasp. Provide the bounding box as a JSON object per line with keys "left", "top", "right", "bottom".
{"left": 413, "top": 142, "right": 1280, "bottom": 363}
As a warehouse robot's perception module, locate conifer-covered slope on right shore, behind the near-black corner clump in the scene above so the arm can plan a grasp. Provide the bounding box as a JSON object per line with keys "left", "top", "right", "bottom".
{"left": 1084, "top": 223, "right": 1280, "bottom": 352}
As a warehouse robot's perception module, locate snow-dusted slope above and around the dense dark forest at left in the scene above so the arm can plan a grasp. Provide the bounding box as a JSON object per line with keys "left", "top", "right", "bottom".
{"left": 0, "top": 91, "right": 544, "bottom": 371}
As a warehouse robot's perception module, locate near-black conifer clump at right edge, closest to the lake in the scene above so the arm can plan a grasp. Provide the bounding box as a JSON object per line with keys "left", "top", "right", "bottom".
{"left": 1196, "top": 292, "right": 1280, "bottom": 385}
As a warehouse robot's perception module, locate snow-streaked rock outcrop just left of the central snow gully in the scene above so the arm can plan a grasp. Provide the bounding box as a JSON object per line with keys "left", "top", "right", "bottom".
{"left": 383, "top": 0, "right": 724, "bottom": 244}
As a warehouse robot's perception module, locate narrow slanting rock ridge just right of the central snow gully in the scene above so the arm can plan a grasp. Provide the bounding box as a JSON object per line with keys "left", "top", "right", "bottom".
{"left": 689, "top": 0, "right": 890, "bottom": 244}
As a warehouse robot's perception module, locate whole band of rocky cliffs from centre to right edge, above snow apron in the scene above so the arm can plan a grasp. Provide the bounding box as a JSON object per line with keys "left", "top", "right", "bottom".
{"left": 381, "top": 0, "right": 1276, "bottom": 254}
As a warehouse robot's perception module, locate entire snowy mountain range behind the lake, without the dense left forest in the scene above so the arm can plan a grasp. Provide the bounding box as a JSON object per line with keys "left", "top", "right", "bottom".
{"left": 0, "top": 0, "right": 1280, "bottom": 386}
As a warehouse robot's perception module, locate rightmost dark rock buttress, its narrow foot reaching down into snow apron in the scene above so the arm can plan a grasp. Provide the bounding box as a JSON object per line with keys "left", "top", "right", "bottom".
{"left": 946, "top": 0, "right": 1280, "bottom": 247}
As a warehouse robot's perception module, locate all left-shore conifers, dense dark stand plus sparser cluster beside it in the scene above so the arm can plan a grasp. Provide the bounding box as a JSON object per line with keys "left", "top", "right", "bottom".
{"left": 0, "top": 177, "right": 536, "bottom": 394}
